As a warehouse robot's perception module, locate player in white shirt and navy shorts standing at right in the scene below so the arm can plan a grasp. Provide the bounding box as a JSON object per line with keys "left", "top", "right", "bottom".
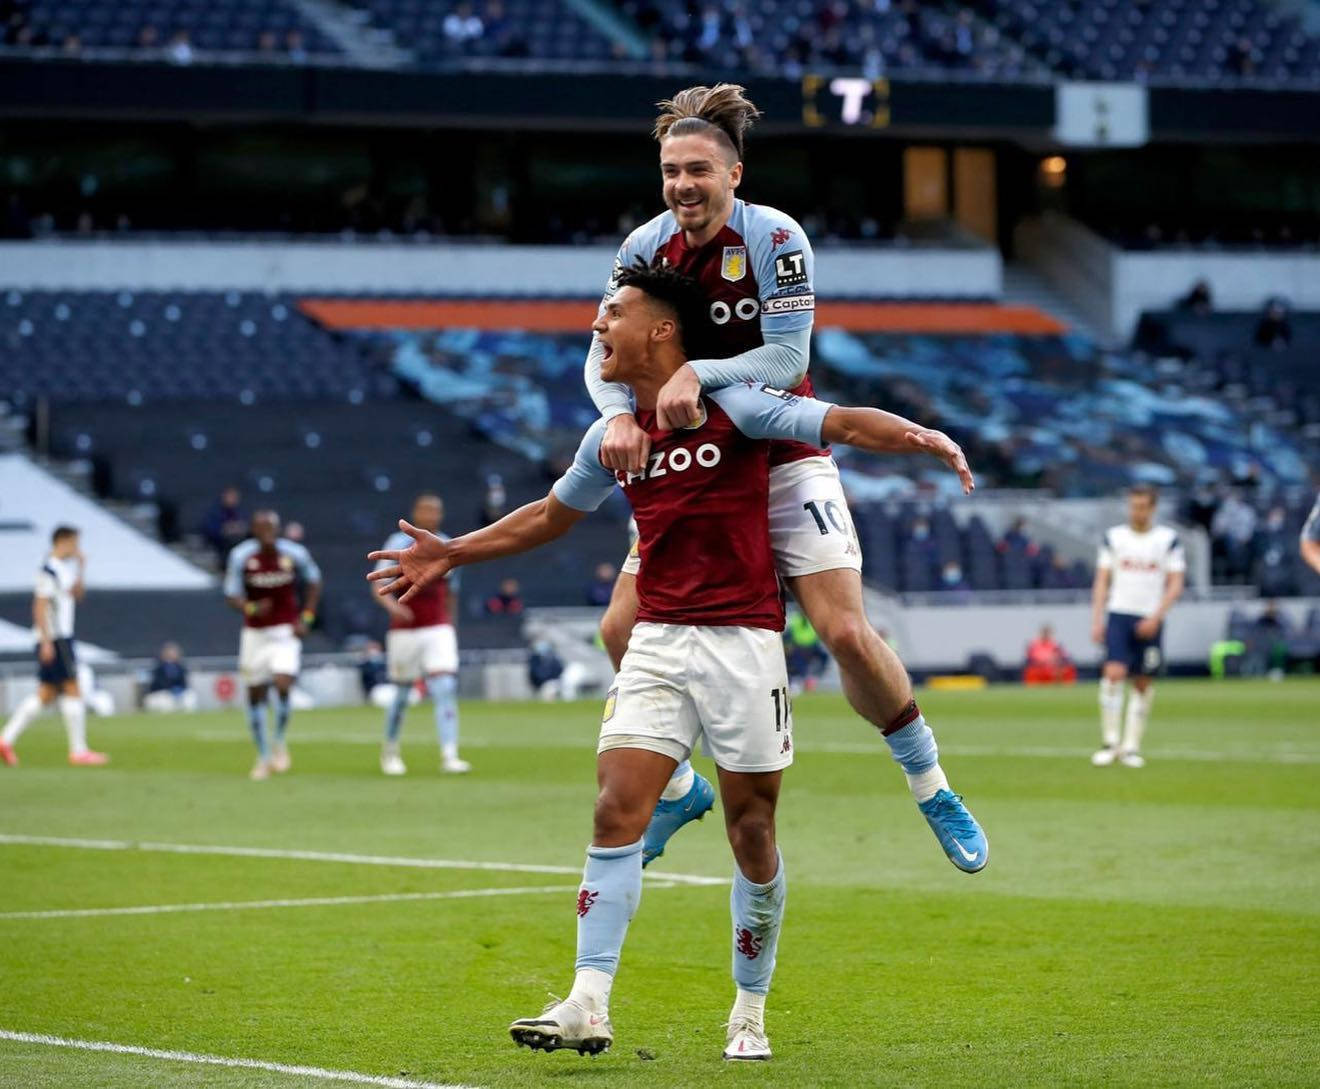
{"left": 1090, "top": 484, "right": 1187, "bottom": 768}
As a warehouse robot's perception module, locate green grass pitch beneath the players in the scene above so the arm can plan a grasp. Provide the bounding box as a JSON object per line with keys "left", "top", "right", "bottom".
{"left": 0, "top": 678, "right": 1320, "bottom": 1089}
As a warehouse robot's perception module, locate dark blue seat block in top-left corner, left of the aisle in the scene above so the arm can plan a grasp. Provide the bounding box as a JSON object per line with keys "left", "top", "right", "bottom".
{"left": 0, "top": 0, "right": 341, "bottom": 61}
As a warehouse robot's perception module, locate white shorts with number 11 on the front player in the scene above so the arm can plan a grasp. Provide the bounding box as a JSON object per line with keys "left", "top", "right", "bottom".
{"left": 597, "top": 622, "right": 793, "bottom": 772}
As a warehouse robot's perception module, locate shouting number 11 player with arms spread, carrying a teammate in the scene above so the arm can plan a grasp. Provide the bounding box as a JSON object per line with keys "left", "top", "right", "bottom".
{"left": 368, "top": 268, "right": 987, "bottom": 1059}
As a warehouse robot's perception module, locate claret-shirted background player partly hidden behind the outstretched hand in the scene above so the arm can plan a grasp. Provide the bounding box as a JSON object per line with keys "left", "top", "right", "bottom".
{"left": 376, "top": 492, "right": 471, "bottom": 775}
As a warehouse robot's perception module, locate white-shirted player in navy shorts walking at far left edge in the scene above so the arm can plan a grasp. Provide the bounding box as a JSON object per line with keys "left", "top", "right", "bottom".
{"left": 0, "top": 525, "right": 110, "bottom": 767}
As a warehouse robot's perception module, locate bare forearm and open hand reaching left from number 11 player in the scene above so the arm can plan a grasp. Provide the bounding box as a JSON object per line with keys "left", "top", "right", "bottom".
{"left": 367, "top": 494, "right": 586, "bottom": 605}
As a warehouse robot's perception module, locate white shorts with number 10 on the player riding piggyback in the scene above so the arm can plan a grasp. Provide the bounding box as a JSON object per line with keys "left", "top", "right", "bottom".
{"left": 620, "top": 457, "right": 862, "bottom": 578}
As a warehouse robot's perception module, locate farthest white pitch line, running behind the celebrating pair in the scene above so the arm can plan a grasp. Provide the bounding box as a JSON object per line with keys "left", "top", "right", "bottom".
{"left": 193, "top": 730, "right": 1320, "bottom": 764}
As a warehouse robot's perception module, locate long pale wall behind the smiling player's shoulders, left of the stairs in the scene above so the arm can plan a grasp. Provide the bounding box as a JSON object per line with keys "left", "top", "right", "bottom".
{"left": 0, "top": 240, "right": 1003, "bottom": 298}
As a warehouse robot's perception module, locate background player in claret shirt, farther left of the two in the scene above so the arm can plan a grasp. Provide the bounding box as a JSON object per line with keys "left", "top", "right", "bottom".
{"left": 224, "top": 511, "right": 321, "bottom": 779}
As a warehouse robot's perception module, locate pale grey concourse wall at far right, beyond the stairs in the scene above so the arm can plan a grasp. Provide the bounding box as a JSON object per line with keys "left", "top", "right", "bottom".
{"left": 1015, "top": 213, "right": 1320, "bottom": 342}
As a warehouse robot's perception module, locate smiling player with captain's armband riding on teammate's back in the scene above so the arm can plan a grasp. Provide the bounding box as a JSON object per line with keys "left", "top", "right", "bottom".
{"left": 586, "top": 83, "right": 986, "bottom": 873}
